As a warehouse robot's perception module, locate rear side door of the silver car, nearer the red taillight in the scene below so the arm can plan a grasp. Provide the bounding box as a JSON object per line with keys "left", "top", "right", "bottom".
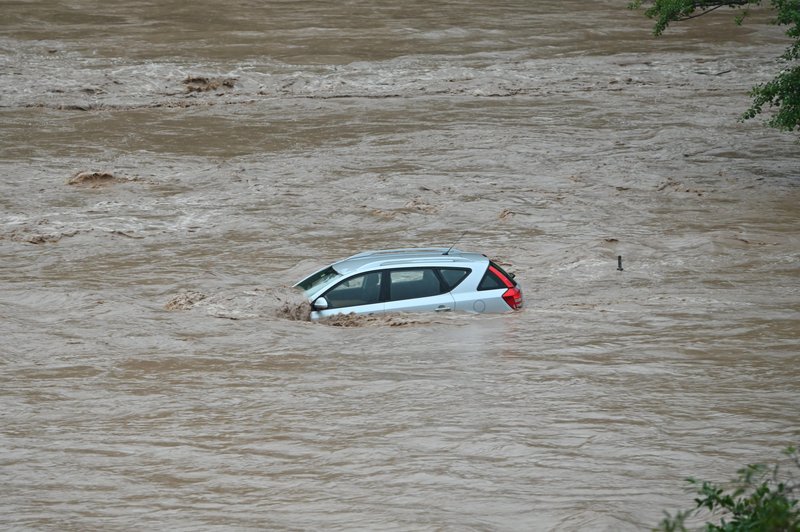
{"left": 384, "top": 268, "right": 455, "bottom": 312}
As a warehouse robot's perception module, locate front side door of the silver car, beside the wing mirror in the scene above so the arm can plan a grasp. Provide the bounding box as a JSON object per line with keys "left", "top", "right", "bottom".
{"left": 311, "top": 271, "right": 384, "bottom": 319}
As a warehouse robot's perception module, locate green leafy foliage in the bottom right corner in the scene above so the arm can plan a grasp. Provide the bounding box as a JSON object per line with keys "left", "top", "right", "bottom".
{"left": 659, "top": 447, "right": 800, "bottom": 532}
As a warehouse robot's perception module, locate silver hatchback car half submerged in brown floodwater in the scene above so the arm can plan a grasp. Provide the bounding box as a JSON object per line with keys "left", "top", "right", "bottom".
{"left": 294, "top": 248, "right": 522, "bottom": 319}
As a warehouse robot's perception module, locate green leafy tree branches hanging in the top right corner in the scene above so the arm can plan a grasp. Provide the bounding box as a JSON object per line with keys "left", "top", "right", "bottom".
{"left": 629, "top": 0, "right": 800, "bottom": 131}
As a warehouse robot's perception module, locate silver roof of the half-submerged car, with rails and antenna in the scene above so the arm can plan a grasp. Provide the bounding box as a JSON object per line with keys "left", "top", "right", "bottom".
{"left": 331, "top": 248, "right": 489, "bottom": 275}
